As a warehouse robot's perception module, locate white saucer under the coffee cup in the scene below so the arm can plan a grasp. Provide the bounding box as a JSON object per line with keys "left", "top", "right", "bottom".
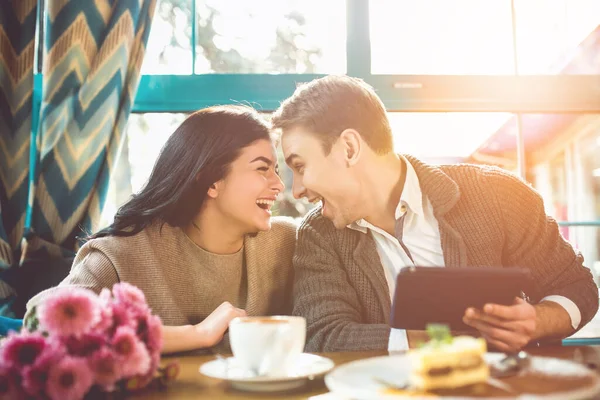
{"left": 200, "top": 353, "right": 335, "bottom": 392}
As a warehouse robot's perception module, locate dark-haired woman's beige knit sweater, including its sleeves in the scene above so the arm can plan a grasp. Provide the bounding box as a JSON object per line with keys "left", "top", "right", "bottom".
{"left": 26, "top": 218, "right": 296, "bottom": 326}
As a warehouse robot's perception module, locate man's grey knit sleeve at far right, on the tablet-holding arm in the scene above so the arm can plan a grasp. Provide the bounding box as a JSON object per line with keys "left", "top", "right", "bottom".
{"left": 490, "top": 167, "right": 598, "bottom": 328}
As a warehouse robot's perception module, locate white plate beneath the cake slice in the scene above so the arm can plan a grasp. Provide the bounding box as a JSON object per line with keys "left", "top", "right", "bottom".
{"left": 325, "top": 353, "right": 600, "bottom": 400}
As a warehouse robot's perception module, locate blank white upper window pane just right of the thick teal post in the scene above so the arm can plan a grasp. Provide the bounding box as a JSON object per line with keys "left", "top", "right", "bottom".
{"left": 370, "top": 0, "right": 513, "bottom": 75}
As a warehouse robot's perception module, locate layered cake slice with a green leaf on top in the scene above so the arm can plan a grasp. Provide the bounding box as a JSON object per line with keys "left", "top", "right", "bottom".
{"left": 409, "top": 331, "right": 490, "bottom": 391}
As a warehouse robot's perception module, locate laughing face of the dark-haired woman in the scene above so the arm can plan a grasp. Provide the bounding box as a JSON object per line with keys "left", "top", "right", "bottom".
{"left": 209, "top": 140, "right": 284, "bottom": 233}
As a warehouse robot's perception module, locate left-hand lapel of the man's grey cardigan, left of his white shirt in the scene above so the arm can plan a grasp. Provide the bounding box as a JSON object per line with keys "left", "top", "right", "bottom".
{"left": 347, "top": 233, "right": 391, "bottom": 323}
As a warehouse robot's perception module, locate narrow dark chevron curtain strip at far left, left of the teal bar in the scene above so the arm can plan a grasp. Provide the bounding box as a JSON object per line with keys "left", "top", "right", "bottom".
{"left": 0, "top": 0, "right": 37, "bottom": 268}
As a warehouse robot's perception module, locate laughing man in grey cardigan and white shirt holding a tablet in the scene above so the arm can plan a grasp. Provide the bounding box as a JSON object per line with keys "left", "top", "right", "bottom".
{"left": 273, "top": 76, "right": 598, "bottom": 351}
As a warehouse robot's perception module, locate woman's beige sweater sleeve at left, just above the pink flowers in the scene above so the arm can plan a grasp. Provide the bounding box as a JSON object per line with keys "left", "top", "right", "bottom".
{"left": 25, "top": 246, "right": 119, "bottom": 320}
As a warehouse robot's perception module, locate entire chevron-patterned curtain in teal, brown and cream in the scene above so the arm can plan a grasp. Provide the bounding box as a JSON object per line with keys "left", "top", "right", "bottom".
{"left": 0, "top": 0, "right": 155, "bottom": 316}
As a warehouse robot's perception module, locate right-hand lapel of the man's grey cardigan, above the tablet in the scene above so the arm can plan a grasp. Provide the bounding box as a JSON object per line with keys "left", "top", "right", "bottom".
{"left": 404, "top": 155, "right": 468, "bottom": 267}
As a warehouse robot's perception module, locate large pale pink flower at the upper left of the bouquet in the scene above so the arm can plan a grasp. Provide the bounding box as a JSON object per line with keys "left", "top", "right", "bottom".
{"left": 39, "top": 287, "right": 100, "bottom": 336}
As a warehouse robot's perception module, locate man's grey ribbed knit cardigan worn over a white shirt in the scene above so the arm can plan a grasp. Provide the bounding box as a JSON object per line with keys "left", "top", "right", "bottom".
{"left": 293, "top": 156, "right": 598, "bottom": 352}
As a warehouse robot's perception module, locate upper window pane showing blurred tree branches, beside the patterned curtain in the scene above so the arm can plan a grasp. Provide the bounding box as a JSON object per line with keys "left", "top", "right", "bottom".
{"left": 142, "top": 0, "right": 346, "bottom": 74}
